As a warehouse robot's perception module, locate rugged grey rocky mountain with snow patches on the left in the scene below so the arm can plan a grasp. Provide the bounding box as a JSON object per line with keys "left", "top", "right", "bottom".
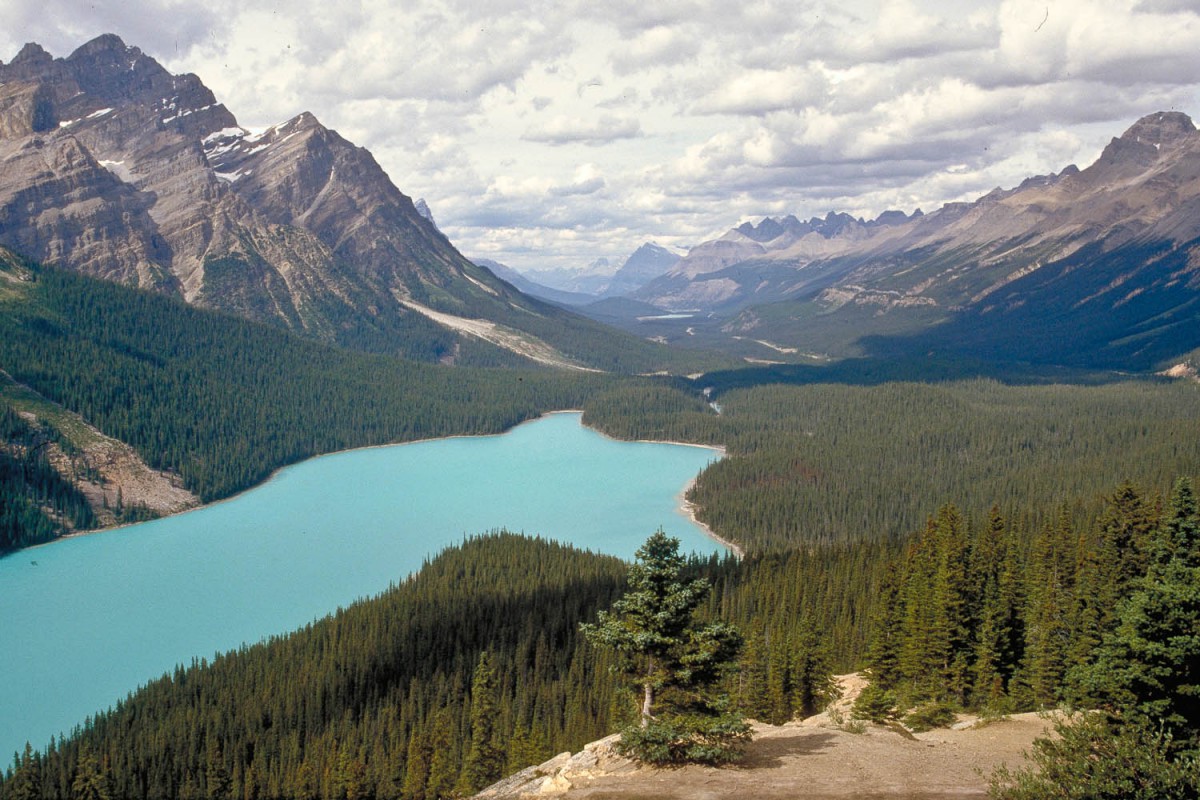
{"left": 0, "top": 35, "right": 686, "bottom": 369}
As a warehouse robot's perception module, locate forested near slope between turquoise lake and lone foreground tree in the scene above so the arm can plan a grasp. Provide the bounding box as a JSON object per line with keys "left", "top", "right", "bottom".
{"left": 0, "top": 534, "right": 624, "bottom": 799}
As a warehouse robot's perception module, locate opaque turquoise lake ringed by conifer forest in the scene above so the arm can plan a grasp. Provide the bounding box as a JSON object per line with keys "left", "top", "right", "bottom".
{"left": 0, "top": 414, "right": 724, "bottom": 766}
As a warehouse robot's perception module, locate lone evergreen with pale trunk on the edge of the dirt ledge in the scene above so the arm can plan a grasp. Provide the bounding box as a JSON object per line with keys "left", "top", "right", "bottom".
{"left": 581, "top": 530, "right": 749, "bottom": 763}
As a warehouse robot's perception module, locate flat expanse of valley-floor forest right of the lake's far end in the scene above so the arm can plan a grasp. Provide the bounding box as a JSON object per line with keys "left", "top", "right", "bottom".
{"left": 583, "top": 379, "right": 1200, "bottom": 551}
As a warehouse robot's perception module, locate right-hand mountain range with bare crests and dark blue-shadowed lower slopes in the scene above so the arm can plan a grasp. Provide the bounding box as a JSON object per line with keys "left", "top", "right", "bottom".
{"left": 631, "top": 112, "right": 1200, "bottom": 369}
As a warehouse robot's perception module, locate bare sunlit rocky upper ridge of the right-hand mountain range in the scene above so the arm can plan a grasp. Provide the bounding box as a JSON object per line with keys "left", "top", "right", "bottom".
{"left": 637, "top": 112, "right": 1200, "bottom": 308}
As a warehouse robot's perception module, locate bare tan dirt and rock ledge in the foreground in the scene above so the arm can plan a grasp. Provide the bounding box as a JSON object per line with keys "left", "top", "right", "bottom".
{"left": 479, "top": 675, "right": 1051, "bottom": 800}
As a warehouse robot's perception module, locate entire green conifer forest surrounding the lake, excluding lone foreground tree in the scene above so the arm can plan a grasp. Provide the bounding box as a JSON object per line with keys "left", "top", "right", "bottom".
{"left": 0, "top": 261, "right": 1200, "bottom": 800}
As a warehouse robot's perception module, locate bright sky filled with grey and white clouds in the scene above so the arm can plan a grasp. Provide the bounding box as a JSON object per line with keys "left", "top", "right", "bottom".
{"left": 0, "top": 0, "right": 1200, "bottom": 269}
